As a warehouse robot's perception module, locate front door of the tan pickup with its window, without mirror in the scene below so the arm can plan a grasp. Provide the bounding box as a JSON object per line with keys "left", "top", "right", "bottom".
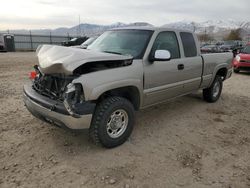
{"left": 144, "top": 31, "right": 187, "bottom": 106}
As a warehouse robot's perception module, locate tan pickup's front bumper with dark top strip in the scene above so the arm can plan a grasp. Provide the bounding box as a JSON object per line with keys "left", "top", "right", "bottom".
{"left": 23, "top": 85, "right": 95, "bottom": 129}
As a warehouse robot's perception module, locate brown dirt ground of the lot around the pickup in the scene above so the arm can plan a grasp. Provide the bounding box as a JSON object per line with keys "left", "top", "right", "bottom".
{"left": 0, "top": 52, "right": 250, "bottom": 188}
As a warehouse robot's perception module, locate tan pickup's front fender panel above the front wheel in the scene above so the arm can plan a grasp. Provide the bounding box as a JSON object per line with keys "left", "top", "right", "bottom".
{"left": 73, "top": 60, "right": 143, "bottom": 103}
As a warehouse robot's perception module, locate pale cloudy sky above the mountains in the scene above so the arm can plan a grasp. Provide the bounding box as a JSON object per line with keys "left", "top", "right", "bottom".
{"left": 0, "top": 0, "right": 250, "bottom": 30}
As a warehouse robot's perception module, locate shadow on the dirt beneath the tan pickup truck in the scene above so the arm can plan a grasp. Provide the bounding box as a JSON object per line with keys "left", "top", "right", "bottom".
{"left": 47, "top": 92, "right": 205, "bottom": 155}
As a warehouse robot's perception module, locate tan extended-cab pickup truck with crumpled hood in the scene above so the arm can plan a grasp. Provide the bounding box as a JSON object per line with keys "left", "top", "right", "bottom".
{"left": 23, "top": 27, "right": 233, "bottom": 148}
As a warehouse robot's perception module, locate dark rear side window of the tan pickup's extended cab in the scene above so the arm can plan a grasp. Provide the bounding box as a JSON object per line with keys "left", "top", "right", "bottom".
{"left": 180, "top": 32, "right": 197, "bottom": 57}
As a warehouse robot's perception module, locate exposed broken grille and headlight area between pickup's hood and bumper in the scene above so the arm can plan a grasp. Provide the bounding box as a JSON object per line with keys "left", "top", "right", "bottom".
{"left": 27, "top": 65, "right": 95, "bottom": 118}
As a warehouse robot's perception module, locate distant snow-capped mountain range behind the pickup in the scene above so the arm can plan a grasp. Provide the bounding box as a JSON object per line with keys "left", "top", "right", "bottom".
{"left": 0, "top": 20, "right": 250, "bottom": 40}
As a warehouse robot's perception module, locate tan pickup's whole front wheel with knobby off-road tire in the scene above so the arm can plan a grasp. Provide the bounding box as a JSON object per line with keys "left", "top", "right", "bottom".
{"left": 89, "top": 97, "right": 135, "bottom": 148}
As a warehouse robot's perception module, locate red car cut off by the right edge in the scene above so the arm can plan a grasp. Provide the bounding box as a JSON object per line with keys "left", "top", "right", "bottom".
{"left": 233, "top": 43, "right": 250, "bottom": 73}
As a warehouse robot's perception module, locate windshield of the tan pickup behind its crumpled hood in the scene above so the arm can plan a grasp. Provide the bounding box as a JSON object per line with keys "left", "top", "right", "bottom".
{"left": 87, "top": 30, "right": 153, "bottom": 59}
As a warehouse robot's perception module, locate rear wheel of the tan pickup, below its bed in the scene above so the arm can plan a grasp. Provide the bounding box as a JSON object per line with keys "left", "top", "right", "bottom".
{"left": 203, "top": 75, "right": 223, "bottom": 103}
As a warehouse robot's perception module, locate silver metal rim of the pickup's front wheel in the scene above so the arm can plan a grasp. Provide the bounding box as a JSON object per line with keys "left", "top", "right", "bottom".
{"left": 107, "top": 109, "right": 128, "bottom": 138}
